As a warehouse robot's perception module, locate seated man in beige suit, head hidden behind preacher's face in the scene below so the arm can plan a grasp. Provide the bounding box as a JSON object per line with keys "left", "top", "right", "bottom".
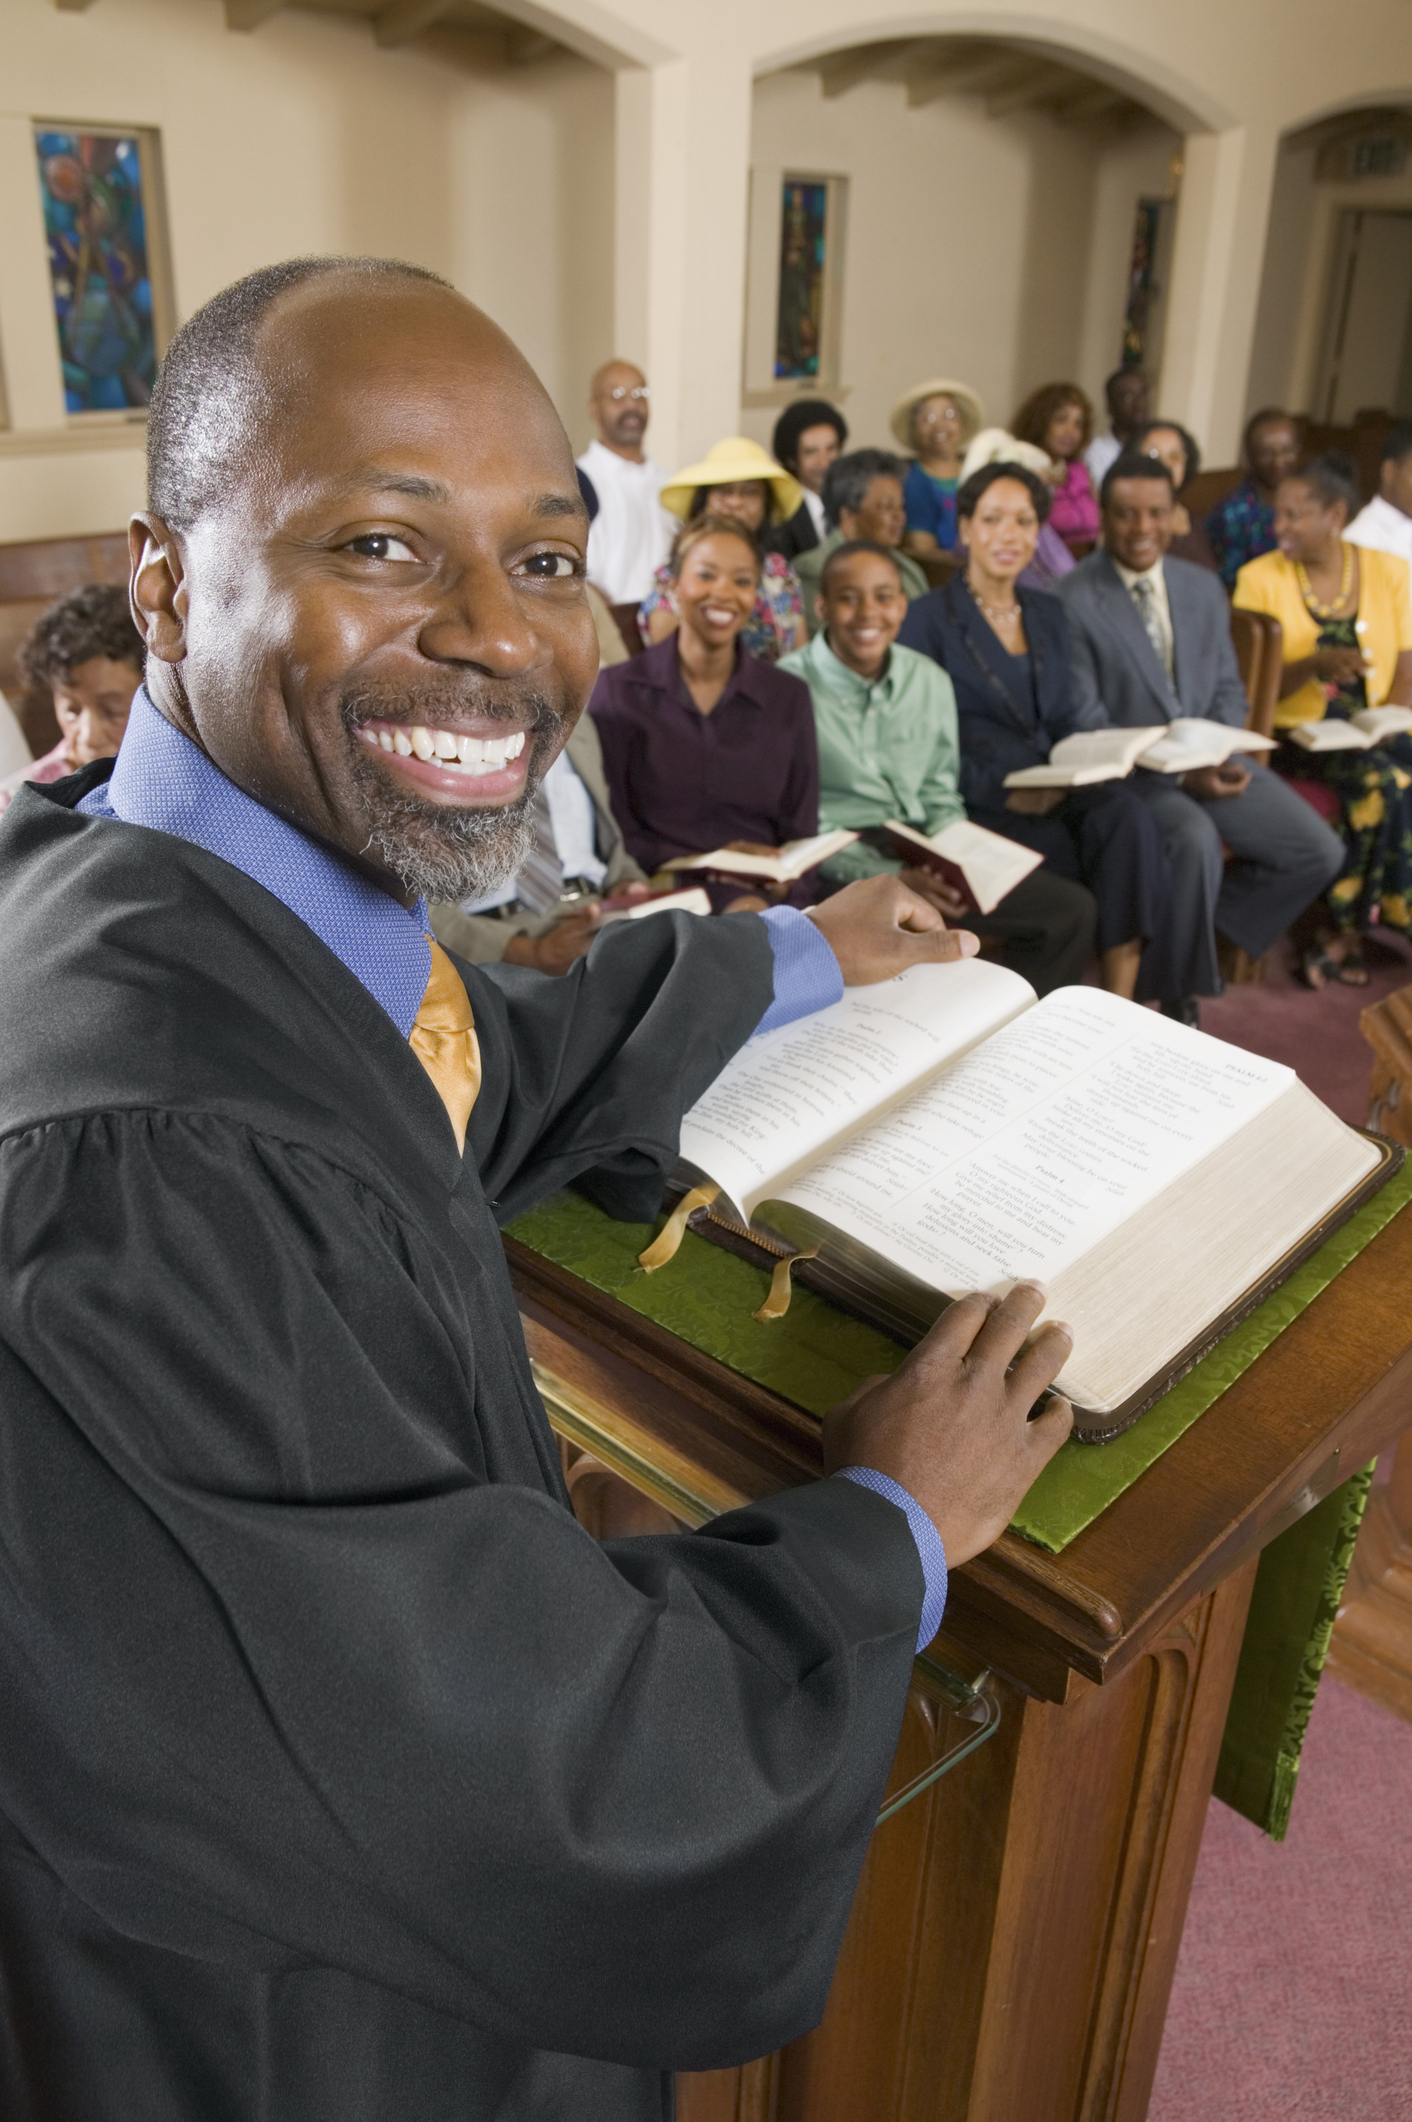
{"left": 431, "top": 715, "right": 648, "bottom": 972}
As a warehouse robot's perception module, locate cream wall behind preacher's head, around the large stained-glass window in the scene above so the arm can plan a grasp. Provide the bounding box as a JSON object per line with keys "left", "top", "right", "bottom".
{"left": 0, "top": 0, "right": 614, "bottom": 539}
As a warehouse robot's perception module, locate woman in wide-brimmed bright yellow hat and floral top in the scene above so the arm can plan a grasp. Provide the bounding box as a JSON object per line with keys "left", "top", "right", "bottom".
{"left": 637, "top": 435, "right": 809, "bottom": 662}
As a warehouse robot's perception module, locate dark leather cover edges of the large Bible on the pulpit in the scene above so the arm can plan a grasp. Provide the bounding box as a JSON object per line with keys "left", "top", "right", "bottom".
{"left": 675, "top": 1127, "right": 1406, "bottom": 1445}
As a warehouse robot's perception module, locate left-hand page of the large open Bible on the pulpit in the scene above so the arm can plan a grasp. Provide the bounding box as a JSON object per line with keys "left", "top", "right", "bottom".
{"left": 682, "top": 957, "right": 1034, "bottom": 1218}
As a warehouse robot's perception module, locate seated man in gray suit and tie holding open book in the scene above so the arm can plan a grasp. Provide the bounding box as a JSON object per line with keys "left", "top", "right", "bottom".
{"left": 1057, "top": 454, "right": 1344, "bottom": 1023}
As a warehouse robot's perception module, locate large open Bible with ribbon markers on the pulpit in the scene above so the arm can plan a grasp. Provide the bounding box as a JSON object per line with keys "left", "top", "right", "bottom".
{"left": 677, "top": 959, "right": 1401, "bottom": 1439}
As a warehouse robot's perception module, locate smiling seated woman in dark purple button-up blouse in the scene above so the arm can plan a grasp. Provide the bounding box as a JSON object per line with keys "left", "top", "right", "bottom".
{"left": 588, "top": 516, "right": 820, "bottom": 910}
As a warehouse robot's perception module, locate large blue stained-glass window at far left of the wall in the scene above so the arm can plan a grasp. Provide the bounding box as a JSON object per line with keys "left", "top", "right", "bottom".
{"left": 34, "top": 123, "right": 166, "bottom": 414}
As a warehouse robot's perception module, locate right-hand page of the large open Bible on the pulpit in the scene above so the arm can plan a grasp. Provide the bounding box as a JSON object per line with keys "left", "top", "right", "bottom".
{"left": 781, "top": 987, "right": 1295, "bottom": 1297}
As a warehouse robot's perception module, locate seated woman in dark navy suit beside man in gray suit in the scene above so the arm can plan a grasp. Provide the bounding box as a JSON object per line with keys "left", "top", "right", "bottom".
{"left": 898, "top": 465, "right": 1172, "bottom": 1002}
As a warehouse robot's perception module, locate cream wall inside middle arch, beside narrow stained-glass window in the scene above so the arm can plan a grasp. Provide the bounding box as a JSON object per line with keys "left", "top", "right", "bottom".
{"left": 741, "top": 70, "right": 1181, "bottom": 462}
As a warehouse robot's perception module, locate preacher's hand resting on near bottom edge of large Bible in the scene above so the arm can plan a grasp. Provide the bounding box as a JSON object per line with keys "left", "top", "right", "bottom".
{"left": 824, "top": 1282, "right": 1074, "bottom": 1568}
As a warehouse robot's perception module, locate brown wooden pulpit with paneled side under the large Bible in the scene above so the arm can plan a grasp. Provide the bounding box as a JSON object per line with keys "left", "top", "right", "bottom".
{"left": 505, "top": 1210, "right": 1412, "bottom": 2122}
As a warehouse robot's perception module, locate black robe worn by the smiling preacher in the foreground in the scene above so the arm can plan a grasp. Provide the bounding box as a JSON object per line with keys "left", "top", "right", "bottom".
{"left": 0, "top": 768, "right": 922, "bottom": 2122}
